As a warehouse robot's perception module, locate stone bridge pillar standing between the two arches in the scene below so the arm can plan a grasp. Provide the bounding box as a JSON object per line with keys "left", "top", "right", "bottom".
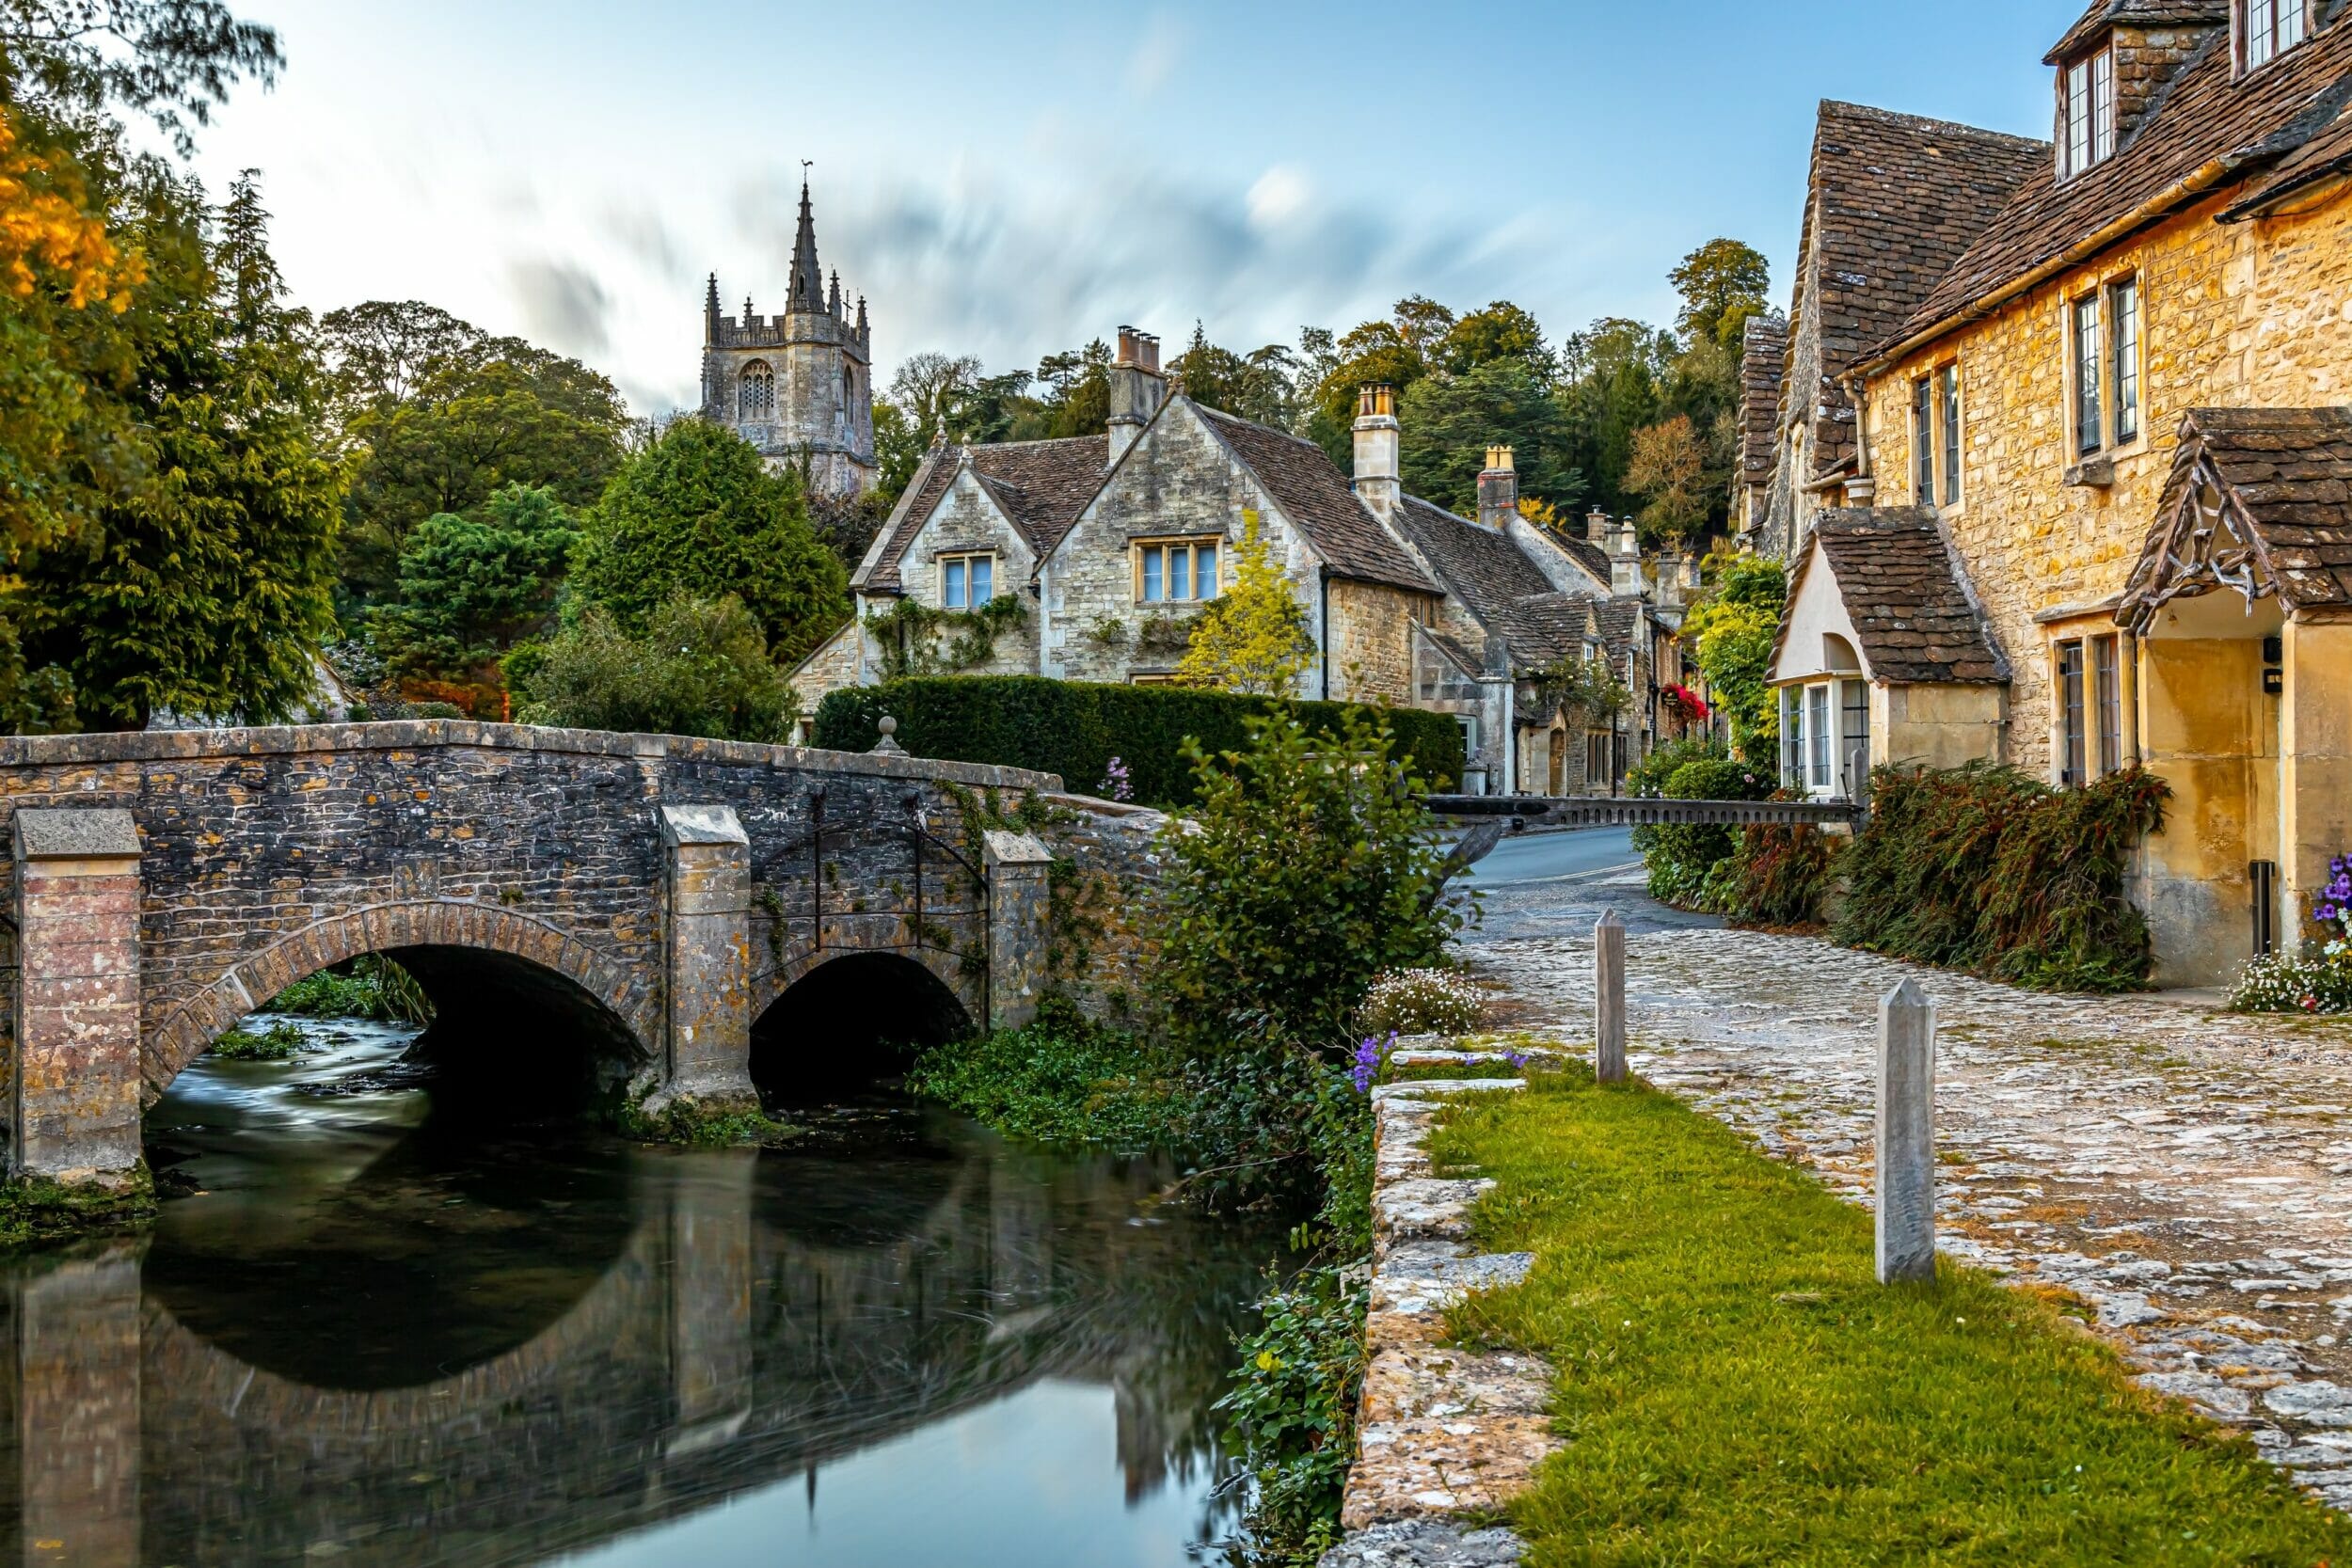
{"left": 659, "top": 806, "right": 753, "bottom": 1101}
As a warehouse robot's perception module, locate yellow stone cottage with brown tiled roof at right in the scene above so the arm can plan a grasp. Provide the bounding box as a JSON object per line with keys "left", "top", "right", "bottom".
{"left": 1757, "top": 0, "right": 2352, "bottom": 985}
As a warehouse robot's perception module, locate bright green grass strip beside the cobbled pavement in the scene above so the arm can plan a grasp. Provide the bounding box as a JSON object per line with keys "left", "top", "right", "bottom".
{"left": 1433, "top": 1077, "right": 2352, "bottom": 1568}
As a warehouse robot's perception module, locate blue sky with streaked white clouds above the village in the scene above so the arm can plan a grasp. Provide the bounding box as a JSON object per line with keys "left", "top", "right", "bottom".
{"left": 198, "top": 0, "right": 2082, "bottom": 414}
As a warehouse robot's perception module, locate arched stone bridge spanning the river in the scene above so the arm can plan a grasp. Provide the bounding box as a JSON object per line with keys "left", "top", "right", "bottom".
{"left": 0, "top": 720, "right": 1155, "bottom": 1180}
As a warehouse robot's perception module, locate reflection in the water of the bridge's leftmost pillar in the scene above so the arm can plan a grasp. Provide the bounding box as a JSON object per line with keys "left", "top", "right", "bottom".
{"left": 9, "top": 1246, "right": 139, "bottom": 1568}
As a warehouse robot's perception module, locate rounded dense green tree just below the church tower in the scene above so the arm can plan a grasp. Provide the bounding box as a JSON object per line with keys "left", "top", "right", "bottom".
{"left": 572, "top": 419, "right": 850, "bottom": 660}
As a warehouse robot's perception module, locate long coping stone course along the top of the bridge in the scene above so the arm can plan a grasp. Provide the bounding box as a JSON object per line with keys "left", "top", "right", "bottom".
{"left": 0, "top": 720, "right": 1061, "bottom": 795}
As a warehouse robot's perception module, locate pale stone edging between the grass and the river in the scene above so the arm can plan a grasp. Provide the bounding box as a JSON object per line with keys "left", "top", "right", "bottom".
{"left": 1322, "top": 1062, "right": 1555, "bottom": 1568}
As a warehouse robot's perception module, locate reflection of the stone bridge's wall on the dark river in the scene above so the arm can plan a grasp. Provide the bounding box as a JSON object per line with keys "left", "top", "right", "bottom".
{"left": 0, "top": 1152, "right": 1263, "bottom": 1568}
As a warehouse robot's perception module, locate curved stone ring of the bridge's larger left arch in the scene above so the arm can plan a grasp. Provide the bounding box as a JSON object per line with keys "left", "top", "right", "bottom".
{"left": 139, "top": 898, "right": 661, "bottom": 1105}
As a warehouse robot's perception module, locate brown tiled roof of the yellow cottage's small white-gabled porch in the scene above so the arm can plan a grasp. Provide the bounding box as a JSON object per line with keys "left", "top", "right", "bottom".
{"left": 1773, "top": 505, "right": 2009, "bottom": 687}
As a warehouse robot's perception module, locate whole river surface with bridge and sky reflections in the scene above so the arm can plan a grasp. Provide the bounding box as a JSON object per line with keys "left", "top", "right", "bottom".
{"left": 0, "top": 1032, "right": 1279, "bottom": 1568}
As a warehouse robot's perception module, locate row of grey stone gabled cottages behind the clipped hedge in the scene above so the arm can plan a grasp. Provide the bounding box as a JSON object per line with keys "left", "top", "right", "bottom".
{"left": 795, "top": 329, "right": 1689, "bottom": 792}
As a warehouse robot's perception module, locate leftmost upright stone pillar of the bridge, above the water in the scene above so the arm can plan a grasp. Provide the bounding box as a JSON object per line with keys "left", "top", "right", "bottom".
{"left": 9, "top": 809, "right": 139, "bottom": 1185}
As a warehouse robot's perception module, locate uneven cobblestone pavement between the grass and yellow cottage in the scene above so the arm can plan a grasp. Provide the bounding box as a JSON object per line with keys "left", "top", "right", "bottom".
{"left": 1470, "top": 902, "right": 2352, "bottom": 1507}
